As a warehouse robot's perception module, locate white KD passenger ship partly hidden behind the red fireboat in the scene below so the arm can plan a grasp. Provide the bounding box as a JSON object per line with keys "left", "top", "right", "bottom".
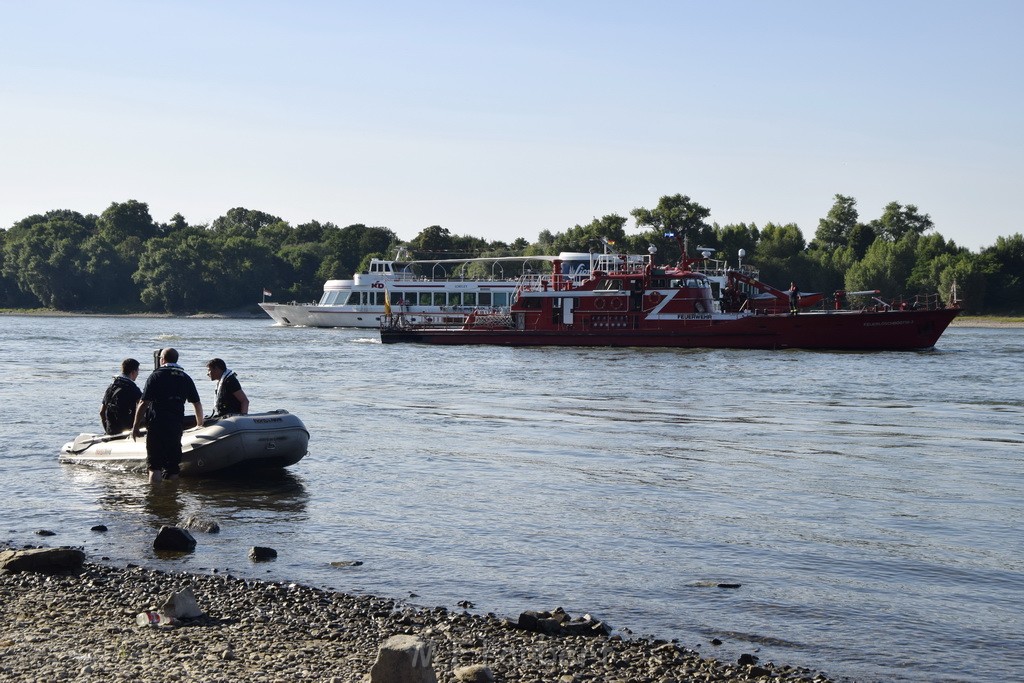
{"left": 260, "top": 253, "right": 590, "bottom": 328}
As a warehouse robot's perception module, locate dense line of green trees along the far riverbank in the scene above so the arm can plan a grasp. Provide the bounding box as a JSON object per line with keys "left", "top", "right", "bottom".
{"left": 0, "top": 195, "right": 1024, "bottom": 314}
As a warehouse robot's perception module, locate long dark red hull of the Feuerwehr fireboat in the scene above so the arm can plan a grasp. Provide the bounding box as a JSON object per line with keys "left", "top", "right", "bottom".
{"left": 381, "top": 308, "right": 959, "bottom": 350}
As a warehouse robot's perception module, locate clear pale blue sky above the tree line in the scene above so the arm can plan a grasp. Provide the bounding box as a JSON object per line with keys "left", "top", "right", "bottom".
{"left": 0, "top": 0, "right": 1024, "bottom": 251}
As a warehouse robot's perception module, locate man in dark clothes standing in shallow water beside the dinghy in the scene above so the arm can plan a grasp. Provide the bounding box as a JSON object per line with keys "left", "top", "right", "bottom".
{"left": 131, "top": 348, "right": 203, "bottom": 483}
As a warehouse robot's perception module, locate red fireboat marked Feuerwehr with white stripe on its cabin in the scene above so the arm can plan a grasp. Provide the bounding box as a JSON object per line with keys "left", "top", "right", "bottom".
{"left": 380, "top": 244, "right": 961, "bottom": 350}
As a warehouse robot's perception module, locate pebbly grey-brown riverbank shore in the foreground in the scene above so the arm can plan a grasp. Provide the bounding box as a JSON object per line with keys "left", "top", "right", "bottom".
{"left": 0, "top": 562, "right": 829, "bottom": 683}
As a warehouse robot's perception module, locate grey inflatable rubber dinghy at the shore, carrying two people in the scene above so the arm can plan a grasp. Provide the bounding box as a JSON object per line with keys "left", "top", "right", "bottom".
{"left": 59, "top": 411, "right": 309, "bottom": 477}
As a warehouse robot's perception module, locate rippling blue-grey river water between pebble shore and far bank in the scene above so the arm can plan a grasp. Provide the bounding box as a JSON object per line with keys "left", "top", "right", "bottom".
{"left": 0, "top": 316, "right": 1024, "bottom": 683}
